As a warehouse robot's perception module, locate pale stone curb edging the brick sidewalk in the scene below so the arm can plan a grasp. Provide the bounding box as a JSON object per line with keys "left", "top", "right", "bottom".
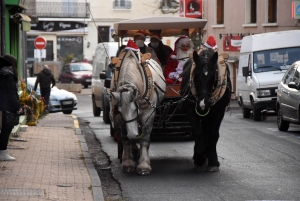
{"left": 71, "top": 115, "right": 105, "bottom": 201}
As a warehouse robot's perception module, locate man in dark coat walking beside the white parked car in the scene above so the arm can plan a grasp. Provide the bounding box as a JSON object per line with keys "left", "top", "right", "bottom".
{"left": 33, "top": 65, "right": 55, "bottom": 108}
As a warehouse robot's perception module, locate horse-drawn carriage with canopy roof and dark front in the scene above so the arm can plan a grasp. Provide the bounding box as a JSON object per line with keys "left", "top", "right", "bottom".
{"left": 106, "top": 17, "right": 207, "bottom": 136}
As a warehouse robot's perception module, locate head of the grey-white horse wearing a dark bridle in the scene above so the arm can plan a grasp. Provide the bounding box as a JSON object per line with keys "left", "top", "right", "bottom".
{"left": 111, "top": 84, "right": 138, "bottom": 137}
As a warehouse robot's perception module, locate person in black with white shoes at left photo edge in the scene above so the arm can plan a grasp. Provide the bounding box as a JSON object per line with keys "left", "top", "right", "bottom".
{"left": 0, "top": 55, "right": 23, "bottom": 161}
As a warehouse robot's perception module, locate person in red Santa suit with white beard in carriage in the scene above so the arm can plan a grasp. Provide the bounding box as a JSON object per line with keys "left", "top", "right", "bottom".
{"left": 164, "top": 36, "right": 194, "bottom": 84}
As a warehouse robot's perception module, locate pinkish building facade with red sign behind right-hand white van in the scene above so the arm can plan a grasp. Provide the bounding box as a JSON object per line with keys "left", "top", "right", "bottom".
{"left": 202, "top": 0, "right": 300, "bottom": 94}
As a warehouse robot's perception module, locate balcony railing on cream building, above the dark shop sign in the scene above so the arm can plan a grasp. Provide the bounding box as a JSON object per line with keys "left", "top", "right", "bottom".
{"left": 36, "top": 2, "right": 90, "bottom": 18}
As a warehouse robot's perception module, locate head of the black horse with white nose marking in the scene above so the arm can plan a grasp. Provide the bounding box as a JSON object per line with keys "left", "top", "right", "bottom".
{"left": 192, "top": 49, "right": 218, "bottom": 110}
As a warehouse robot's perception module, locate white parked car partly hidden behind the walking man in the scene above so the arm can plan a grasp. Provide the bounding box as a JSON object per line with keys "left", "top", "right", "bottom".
{"left": 27, "top": 77, "right": 77, "bottom": 114}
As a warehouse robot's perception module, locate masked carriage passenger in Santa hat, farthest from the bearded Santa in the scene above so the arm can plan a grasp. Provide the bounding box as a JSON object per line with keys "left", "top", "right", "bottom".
{"left": 133, "top": 30, "right": 159, "bottom": 63}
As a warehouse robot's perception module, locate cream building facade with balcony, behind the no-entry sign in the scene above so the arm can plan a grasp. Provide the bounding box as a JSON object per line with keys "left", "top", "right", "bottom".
{"left": 27, "top": 0, "right": 178, "bottom": 66}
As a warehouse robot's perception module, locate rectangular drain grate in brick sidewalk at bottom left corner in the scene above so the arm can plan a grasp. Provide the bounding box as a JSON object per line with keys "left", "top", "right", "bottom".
{"left": 0, "top": 188, "right": 45, "bottom": 196}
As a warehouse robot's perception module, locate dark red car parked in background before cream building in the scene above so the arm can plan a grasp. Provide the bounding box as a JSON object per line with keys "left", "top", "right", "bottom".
{"left": 58, "top": 62, "right": 93, "bottom": 88}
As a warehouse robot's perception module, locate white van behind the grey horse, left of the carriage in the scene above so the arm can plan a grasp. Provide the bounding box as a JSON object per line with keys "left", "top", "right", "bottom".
{"left": 92, "top": 42, "right": 118, "bottom": 123}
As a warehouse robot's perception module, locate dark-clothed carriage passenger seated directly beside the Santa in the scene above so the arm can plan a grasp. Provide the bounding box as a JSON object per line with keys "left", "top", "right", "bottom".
{"left": 148, "top": 34, "right": 173, "bottom": 66}
